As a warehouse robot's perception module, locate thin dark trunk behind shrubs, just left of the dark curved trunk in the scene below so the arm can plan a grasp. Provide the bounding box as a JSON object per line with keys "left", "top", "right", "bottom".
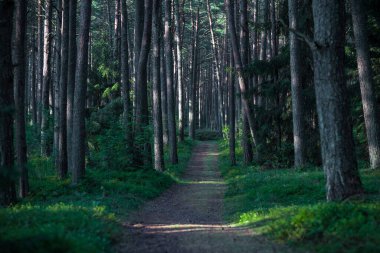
{"left": 120, "top": 0, "right": 133, "bottom": 151}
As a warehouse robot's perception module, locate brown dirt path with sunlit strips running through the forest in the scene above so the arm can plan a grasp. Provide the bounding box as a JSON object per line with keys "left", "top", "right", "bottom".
{"left": 118, "top": 142, "right": 292, "bottom": 253}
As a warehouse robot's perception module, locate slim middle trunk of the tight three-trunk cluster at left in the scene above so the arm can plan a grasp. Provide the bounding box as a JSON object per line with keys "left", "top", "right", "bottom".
{"left": 67, "top": 0, "right": 77, "bottom": 171}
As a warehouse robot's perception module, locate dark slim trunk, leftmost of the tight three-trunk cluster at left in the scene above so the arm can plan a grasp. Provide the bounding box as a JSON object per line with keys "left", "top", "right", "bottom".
{"left": 57, "top": 0, "right": 69, "bottom": 179}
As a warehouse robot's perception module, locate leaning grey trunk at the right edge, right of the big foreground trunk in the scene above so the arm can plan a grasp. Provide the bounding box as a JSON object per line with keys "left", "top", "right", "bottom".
{"left": 351, "top": 0, "right": 380, "bottom": 169}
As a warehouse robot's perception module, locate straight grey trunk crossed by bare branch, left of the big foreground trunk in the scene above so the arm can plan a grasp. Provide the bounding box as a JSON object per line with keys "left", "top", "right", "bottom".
{"left": 288, "top": 0, "right": 305, "bottom": 168}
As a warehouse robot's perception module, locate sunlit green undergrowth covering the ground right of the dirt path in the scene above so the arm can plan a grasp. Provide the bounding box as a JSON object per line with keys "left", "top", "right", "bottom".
{"left": 219, "top": 143, "right": 380, "bottom": 252}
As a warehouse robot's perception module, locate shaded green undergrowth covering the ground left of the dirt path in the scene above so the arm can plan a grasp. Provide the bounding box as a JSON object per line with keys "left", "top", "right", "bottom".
{"left": 0, "top": 141, "right": 193, "bottom": 253}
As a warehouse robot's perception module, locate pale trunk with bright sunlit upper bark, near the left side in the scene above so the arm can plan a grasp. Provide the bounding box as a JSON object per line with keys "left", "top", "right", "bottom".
{"left": 41, "top": 0, "right": 53, "bottom": 156}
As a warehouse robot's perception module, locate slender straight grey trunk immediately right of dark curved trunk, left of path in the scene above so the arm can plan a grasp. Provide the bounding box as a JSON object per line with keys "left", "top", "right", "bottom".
{"left": 152, "top": 0, "right": 164, "bottom": 171}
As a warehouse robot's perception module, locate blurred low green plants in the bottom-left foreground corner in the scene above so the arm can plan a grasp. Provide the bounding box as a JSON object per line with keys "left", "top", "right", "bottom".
{"left": 0, "top": 203, "right": 118, "bottom": 253}
